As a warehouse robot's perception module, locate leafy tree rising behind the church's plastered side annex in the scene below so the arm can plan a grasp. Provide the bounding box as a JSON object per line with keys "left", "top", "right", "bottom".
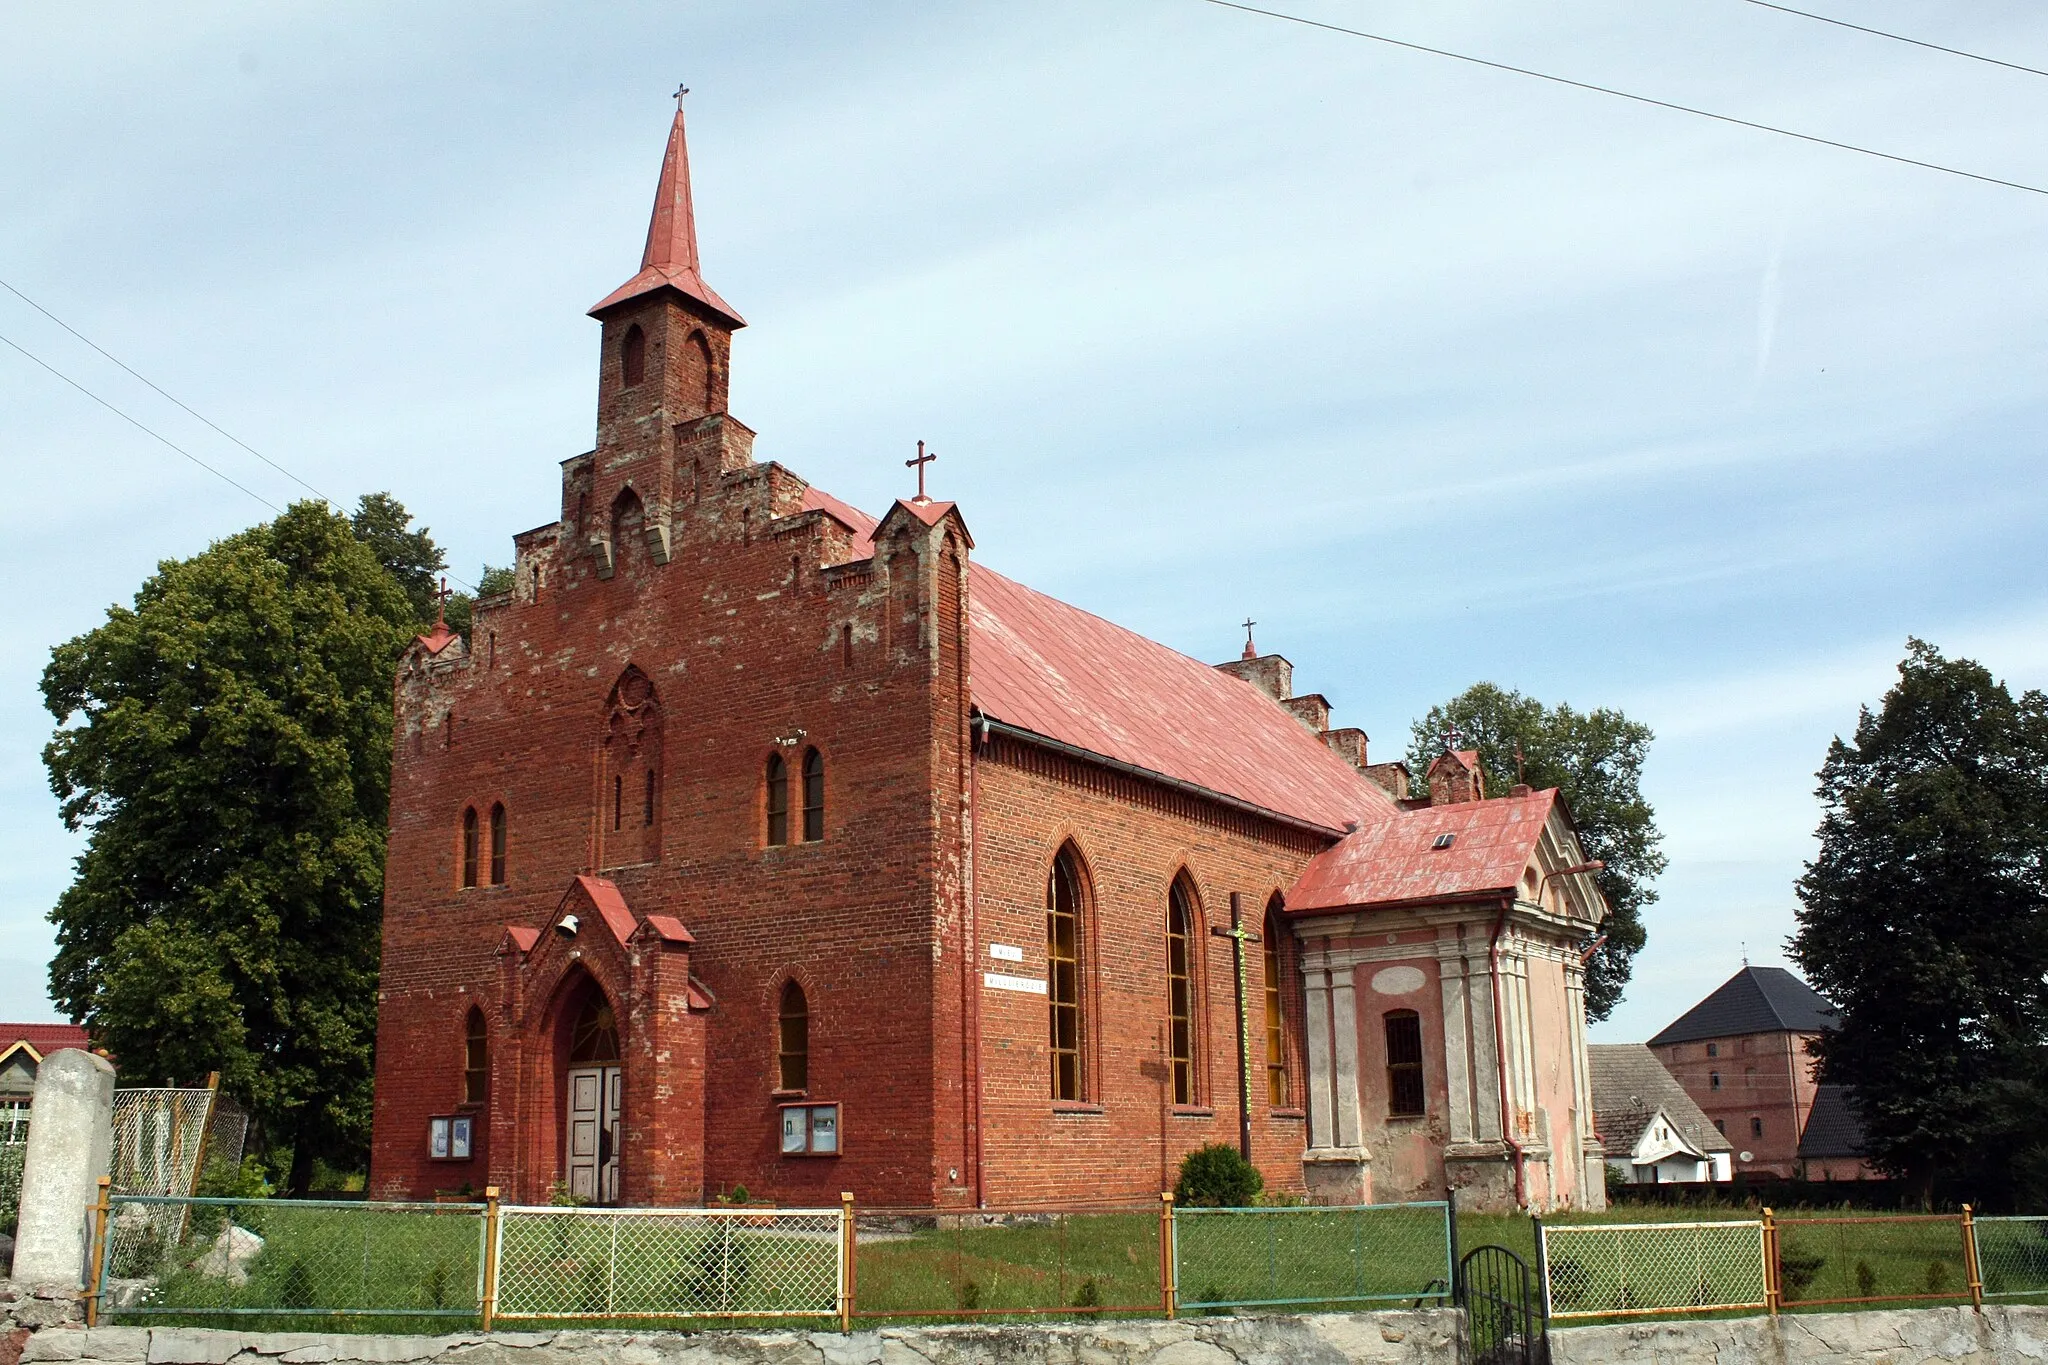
{"left": 1407, "top": 684, "right": 1667, "bottom": 1021}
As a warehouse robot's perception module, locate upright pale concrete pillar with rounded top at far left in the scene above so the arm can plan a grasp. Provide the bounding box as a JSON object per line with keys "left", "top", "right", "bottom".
{"left": 14, "top": 1048, "right": 115, "bottom": 1287}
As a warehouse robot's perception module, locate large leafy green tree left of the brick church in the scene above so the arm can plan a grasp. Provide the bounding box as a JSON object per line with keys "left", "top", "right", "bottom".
{"left": 43, "top": 499, "right": 418, "bottom": 1191}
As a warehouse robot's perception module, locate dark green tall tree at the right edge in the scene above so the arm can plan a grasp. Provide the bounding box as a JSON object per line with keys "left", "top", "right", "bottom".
{"left": 1792, "top": 641, "right": 2048, "bottom": 1207}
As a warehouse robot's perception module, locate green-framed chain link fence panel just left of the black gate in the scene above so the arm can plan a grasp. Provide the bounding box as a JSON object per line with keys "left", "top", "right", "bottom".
{"left": 1171, "top": 1203, "right": 1452, "bottom": 1312}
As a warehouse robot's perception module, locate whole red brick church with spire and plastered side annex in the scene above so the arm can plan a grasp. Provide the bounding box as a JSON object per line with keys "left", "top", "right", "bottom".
{"left": 371, "top": 111, "right": 1606, "bottom": 1207}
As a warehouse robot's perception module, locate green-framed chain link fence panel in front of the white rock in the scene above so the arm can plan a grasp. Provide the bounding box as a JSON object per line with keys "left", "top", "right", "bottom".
{"left": 96, "top": 1195, "right": 485, "bottom": 1330}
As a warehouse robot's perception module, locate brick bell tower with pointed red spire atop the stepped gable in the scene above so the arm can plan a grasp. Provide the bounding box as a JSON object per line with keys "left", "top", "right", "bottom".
{"left": 581, "top": 90, "right": 748, "bottom": 577}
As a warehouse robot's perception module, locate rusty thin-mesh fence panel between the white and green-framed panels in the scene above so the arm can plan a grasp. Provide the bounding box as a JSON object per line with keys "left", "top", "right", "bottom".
{"left": 854, "top": 1201, "right": 1165, "bottom": 1320}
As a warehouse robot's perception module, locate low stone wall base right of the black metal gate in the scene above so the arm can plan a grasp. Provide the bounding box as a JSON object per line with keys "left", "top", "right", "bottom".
{"left": 1550, "top": 1306, "right": 2048, "bottom": 1365}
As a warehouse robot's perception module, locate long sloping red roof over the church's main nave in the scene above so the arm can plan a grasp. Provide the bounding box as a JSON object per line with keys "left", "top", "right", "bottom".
{"left": 803, "top": 489, "right": 1395, "bottom": 831}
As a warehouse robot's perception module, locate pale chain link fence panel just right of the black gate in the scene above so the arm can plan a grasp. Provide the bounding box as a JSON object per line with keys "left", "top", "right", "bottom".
{"left": 1538, "top": 1220, "right": 1769, "bottom": 1318}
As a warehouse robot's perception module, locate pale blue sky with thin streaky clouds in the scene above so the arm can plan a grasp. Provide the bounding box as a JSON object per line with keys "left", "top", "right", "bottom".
{"left": 0, "top": 0, "right": 2048, "bottom": 1042}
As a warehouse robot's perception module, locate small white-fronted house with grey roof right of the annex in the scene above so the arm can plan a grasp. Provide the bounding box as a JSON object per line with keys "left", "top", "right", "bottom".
{"left": 1585, "top": 1044, "right": 1733, "bottom": 1185}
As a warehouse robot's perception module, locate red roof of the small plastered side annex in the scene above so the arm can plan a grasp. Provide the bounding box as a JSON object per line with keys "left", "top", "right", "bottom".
{"left": 1286, "top": 788, "right": 1556, "bottom": 913}
